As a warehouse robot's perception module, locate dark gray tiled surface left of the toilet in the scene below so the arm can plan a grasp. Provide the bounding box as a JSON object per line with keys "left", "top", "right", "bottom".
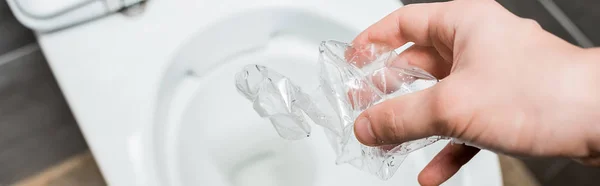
{"left": 0, "top": 0, "right": 87, "bottom": 185}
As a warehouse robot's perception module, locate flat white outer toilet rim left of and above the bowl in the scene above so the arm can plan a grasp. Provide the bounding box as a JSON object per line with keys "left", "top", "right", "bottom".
{"left": 32, "top": 0, "right": 500, "bottom": 186}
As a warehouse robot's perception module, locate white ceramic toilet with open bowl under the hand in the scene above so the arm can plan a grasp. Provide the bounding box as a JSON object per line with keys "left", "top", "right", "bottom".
{"left": 8, "top": 0, "right": 502, "bottom": 186}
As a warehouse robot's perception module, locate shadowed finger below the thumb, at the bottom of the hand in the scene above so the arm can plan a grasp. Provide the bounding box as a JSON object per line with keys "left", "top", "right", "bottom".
{"left": 418, "top": 143, "right": 480, "bottom": 185}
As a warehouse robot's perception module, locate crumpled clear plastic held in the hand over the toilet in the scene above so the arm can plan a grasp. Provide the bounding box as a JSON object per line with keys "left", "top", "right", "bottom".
{"left": 236, "top": 41, "right": 441, "bottom": 180}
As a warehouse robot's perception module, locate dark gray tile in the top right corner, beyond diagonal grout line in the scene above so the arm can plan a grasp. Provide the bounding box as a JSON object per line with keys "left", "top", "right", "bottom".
{"left": 554, "top": 0, "right": 600, "bottom": 46}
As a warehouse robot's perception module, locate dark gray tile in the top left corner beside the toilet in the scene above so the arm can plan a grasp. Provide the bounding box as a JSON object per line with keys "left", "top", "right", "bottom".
{"left": 0, "top": 1, "right": 35, "bottom": 55}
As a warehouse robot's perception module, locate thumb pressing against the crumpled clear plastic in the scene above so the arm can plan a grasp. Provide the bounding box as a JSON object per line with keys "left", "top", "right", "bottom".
{"left": 354, "top": 82, "right": 446, "bottom": 146}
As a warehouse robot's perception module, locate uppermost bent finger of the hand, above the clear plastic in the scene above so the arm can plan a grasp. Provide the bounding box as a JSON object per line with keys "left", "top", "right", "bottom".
{"left": 352, "top": 0, "right": 510, "bottom": 61}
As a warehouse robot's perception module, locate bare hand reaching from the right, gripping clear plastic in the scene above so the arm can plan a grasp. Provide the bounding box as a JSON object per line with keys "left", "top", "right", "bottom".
{"left": 353, "top": 0, "right": 600, "bottom": 185}
